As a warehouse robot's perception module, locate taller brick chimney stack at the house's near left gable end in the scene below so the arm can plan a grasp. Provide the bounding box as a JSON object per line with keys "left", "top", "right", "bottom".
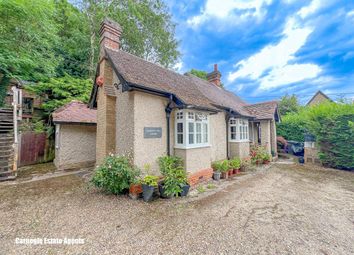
{"left": 100, "top": 18, "right": 122, "bottom": 50}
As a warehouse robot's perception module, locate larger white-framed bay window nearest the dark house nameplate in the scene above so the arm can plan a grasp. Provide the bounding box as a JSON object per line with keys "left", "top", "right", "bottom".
{"left": 175, "top": 110, "right": 209, "bottom": 149}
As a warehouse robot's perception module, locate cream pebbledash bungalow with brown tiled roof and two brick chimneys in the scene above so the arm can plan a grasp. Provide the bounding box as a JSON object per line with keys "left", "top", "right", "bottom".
{"left": 90, "top": 19, "right": 279, "bottom": 178}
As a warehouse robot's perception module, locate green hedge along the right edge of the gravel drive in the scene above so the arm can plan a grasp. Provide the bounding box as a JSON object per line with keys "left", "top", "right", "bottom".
{"left": 277, "top": 102, "right": 354, "bottom": 170}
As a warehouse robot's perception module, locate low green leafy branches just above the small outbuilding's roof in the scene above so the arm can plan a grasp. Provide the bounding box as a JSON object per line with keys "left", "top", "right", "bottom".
{"left": 26, "top": 74, "right": 92, "bottom": 115}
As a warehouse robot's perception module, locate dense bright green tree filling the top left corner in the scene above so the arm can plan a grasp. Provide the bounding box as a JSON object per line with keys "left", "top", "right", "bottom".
{"left": 0, "top": 0, "right": 60, "bottom": 81}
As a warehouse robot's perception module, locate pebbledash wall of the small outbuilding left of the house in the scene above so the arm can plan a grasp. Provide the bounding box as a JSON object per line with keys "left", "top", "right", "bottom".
{"left": 54, "top": 124, "right": 96, "bottom": 170}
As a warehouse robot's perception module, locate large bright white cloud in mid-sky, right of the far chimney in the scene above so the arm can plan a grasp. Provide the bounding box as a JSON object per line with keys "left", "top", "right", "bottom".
{"left": 228, "top": 15, "right": 321, "bottom": 90}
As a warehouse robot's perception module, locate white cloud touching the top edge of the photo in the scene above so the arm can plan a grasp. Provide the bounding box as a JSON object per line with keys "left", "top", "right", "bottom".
{"left": 187, "top": 0, "right": 272, "bottom": 27}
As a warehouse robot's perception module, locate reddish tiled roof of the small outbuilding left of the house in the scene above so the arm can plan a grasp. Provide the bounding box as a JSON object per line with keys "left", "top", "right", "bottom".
{"left": 53, "top": 101, "right": 97, "bottom": 124}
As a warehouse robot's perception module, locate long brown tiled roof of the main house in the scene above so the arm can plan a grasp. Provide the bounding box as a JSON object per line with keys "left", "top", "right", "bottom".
{"left": 105, "top": 48, "right": 276, "bottom": 119}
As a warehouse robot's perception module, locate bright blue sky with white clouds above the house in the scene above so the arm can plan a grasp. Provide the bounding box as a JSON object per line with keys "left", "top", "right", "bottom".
{"left": 166, "top": 0, "right": 354, "bottom": 103}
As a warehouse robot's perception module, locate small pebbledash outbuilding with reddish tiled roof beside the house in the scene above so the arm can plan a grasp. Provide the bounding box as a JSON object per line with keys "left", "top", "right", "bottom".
{"left": 53, "top": 101, "right": 97, "bottom": 170}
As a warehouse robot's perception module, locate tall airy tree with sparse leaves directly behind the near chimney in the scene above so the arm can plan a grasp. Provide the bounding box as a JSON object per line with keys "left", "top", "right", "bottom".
{"left": 78, "top": 0, "right": 180, "bottom": 74}
